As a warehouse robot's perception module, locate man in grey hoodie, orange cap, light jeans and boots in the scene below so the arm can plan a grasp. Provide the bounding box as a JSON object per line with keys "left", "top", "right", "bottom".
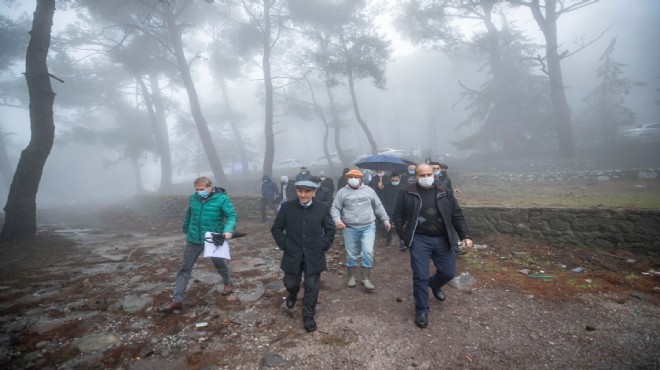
{"left": 330, "top": 170, "right": 391, "bottom": 291}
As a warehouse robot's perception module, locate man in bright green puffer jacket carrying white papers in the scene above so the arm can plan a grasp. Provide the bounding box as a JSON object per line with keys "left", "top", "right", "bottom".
{"left": 159, "top": 177, "right": 236, "bottom": 312}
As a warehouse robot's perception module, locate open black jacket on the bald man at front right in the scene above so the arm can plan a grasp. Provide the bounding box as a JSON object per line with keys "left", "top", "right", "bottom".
{"left": 392, "top": 184, "right": 470, "bottom": 248}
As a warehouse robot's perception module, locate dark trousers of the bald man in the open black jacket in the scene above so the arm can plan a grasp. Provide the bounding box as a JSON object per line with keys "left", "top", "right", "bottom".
{"left": 410, "top": 234, "right": 456, "bottom": 313}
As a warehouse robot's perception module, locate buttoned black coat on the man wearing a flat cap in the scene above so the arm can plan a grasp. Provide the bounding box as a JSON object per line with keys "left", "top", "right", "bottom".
{"left": 270, "top": 199, "right": 336, "bottom": 274}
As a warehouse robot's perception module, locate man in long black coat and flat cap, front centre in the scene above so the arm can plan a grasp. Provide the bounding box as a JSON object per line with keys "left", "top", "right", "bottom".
{"left": 270, "top": 180, "right": 336, "bottom": 332}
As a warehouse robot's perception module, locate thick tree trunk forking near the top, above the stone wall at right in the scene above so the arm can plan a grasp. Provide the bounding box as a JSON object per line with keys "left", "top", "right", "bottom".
{"left": 530, "top": 0, "right": 575, "bottom": 158}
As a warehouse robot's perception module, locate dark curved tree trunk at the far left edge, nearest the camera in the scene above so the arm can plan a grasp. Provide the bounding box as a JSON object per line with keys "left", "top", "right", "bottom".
{"left": 0, "top": 0, "right": 55, "bottom": 241}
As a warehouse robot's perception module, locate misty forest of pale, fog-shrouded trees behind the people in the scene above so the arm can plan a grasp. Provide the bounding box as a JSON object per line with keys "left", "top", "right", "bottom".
{"left": 0, "top": 0, "right": 660, "bottom": 239}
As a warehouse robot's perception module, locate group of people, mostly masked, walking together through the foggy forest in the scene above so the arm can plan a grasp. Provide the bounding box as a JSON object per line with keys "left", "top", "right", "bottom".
{"left": 161, "top": 163, "right": 472, "bottom": 332}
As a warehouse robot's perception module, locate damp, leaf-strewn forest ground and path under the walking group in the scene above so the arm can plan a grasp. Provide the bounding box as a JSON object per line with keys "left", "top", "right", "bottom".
{"left": 0, "top": 178, "right": 660, "bottom": 370}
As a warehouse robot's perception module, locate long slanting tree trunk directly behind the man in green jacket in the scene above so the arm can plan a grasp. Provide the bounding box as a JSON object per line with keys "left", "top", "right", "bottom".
{"left": 163, "top": 5, "right": 228, "bottom": 183}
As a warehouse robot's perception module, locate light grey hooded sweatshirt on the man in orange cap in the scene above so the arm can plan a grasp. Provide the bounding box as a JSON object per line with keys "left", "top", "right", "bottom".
{"left": 330, "top": 184, "right": 390, "bottom": 227}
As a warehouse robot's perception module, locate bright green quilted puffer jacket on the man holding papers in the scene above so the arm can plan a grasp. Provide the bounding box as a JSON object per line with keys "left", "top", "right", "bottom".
{"left": 183, "top": 187, "right": 236, "bottom": 244}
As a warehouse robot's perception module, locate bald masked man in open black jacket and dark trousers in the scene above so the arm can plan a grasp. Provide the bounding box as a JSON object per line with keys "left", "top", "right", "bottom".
{"left": 392, "top": 164, "right": 472, "bottom": 328}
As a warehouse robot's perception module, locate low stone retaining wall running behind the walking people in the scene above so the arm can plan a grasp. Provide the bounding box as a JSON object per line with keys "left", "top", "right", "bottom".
{"left": 135, "top": 195, "right": 660, "bottom": 250}
